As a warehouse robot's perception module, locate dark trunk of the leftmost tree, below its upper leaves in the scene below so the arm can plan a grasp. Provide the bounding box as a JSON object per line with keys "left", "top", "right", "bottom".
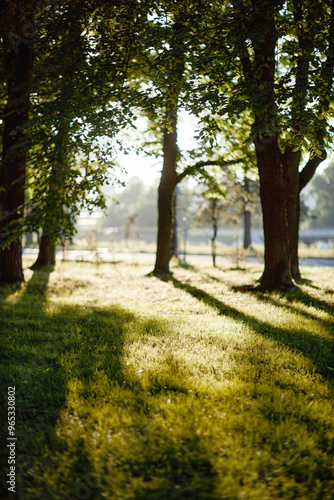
{"left": 0, "top": 35, "right": 33, "bottom": 283}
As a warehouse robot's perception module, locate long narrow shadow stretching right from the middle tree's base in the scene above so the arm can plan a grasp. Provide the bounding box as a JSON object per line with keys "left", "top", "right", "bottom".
{"left": 172, "top": 278, "right": 334, "bottom": 384}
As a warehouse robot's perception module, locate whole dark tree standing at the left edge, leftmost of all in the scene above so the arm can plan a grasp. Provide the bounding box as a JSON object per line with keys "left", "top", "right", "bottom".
{"left": 0, "top": 0, "right": 36, "bottom": 284}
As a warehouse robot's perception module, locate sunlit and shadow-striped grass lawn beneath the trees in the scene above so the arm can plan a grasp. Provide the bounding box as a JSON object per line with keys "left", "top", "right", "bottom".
{"left": 0, "top": 261, "right": 334, "bottom": 500}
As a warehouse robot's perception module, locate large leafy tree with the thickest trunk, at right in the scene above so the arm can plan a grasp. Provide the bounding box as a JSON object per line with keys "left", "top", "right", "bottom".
{"left": 196, "top": 0, "right": 334, "bottom": 290}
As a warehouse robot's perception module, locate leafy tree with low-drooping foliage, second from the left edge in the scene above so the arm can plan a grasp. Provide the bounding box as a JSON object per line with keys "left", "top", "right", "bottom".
{"left": 25, "top": 2, "right": 132, "bottom": 269}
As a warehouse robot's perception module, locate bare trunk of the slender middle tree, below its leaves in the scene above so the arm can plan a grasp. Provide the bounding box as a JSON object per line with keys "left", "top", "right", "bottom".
{"left": 153, "top": 120, "right": 178, "bottom": 276}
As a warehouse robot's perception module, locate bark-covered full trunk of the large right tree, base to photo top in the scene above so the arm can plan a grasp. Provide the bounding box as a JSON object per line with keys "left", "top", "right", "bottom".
{"left": 250, "top": 2, "right": 293, "bottom": 291}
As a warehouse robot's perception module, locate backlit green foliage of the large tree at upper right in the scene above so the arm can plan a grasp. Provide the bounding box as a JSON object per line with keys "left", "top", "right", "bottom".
{"left": 195, "top": 0, "right": 334, "bottom": 157}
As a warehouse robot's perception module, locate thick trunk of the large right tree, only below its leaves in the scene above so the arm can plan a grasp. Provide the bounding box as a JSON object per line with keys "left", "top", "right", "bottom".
{"left": 255, "top": 137, "right": 293, "bottom": 290}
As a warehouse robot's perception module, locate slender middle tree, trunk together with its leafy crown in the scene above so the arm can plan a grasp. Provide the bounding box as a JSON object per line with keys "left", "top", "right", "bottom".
{"left": 111, "top": 0, "right": 220, "bottom": 275}
